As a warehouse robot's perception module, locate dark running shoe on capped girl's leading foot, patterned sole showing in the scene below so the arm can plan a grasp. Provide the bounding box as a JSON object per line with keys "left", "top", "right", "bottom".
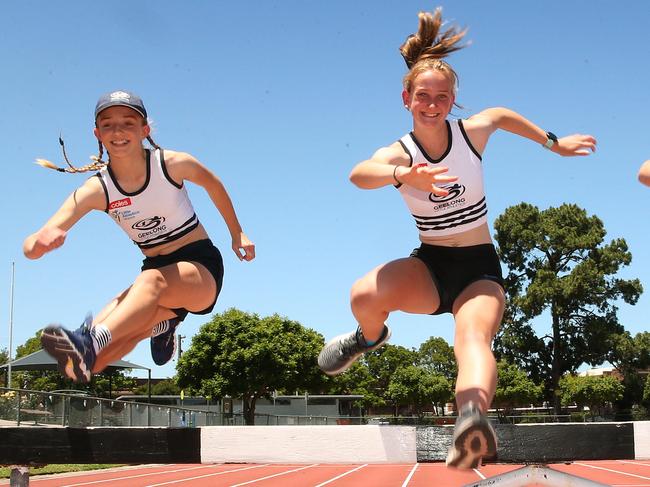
{"left": 41, "top": 317, "right": 96, "bottom": 382}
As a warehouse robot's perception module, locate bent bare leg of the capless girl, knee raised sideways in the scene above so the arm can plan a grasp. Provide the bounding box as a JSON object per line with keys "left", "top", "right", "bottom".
{"left": 350, "top": 257, "right": 440, "bottom": 340}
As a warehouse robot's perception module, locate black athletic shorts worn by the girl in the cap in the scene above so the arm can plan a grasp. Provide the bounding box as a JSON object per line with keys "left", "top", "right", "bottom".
{"left": 141, "top": 239, "right": 223, "bottom": 321}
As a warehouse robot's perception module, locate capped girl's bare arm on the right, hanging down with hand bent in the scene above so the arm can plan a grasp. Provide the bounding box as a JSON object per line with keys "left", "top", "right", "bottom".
{"left": 165, "top": 151, "right": 255, "bottom": 261}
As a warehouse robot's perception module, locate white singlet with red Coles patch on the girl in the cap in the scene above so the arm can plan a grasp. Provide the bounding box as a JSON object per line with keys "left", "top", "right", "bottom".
{"left": 97, "top": 149, "right": 199, "bottom": 249}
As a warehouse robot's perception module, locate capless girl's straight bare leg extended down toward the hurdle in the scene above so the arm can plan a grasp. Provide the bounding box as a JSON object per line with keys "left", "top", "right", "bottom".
{"left": 453, "top": 280, "right": 505, "bottom": 413}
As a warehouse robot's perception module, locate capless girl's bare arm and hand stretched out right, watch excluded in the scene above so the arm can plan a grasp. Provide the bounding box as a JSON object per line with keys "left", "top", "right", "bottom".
{"left": 464, "top": 108, "right": 596, "bottom": 156}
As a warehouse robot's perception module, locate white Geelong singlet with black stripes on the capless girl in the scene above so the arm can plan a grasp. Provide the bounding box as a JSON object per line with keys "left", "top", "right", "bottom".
{"left": 396, "top": 120, "right": 487, "bottom": 237}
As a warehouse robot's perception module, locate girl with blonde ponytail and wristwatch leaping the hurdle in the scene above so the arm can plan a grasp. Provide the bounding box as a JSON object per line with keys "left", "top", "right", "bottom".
{"left": 318, "top": 9, "right": 596, "bottom": 468}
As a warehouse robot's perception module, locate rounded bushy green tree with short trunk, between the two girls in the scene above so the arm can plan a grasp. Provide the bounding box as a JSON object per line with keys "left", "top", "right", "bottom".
{"left": 176, "top": 308, "right": 325, "bottom": 424}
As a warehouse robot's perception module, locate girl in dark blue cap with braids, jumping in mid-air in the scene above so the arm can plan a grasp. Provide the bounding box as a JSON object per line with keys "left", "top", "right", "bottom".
{"left": 23, "top": 91, "right": 255, "bottom": 382}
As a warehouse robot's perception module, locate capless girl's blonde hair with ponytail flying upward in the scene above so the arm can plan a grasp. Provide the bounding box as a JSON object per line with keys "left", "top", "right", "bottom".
{"left": 399, "top": 7, "right": 467, "bottom": 95}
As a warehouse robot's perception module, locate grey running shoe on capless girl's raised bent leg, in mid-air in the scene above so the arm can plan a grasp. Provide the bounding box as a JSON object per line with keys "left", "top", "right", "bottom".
{"left": 318, "top": 325, "right": 390, "bottom": 375}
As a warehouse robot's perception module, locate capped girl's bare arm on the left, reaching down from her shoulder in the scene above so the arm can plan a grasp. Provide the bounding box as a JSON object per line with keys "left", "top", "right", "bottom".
{"left": 23, "top": 177, "right": 106, "bottom": 259}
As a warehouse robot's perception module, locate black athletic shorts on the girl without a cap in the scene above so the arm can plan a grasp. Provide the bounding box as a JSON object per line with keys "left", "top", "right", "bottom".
{"left": 411, "top": 244, "right": 503, "bottom": 315}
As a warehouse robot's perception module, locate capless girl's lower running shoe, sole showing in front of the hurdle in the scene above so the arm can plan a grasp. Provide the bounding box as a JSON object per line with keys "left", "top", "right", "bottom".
{"left": 447, "top": 403, "right": 497, "bottom": 469}
